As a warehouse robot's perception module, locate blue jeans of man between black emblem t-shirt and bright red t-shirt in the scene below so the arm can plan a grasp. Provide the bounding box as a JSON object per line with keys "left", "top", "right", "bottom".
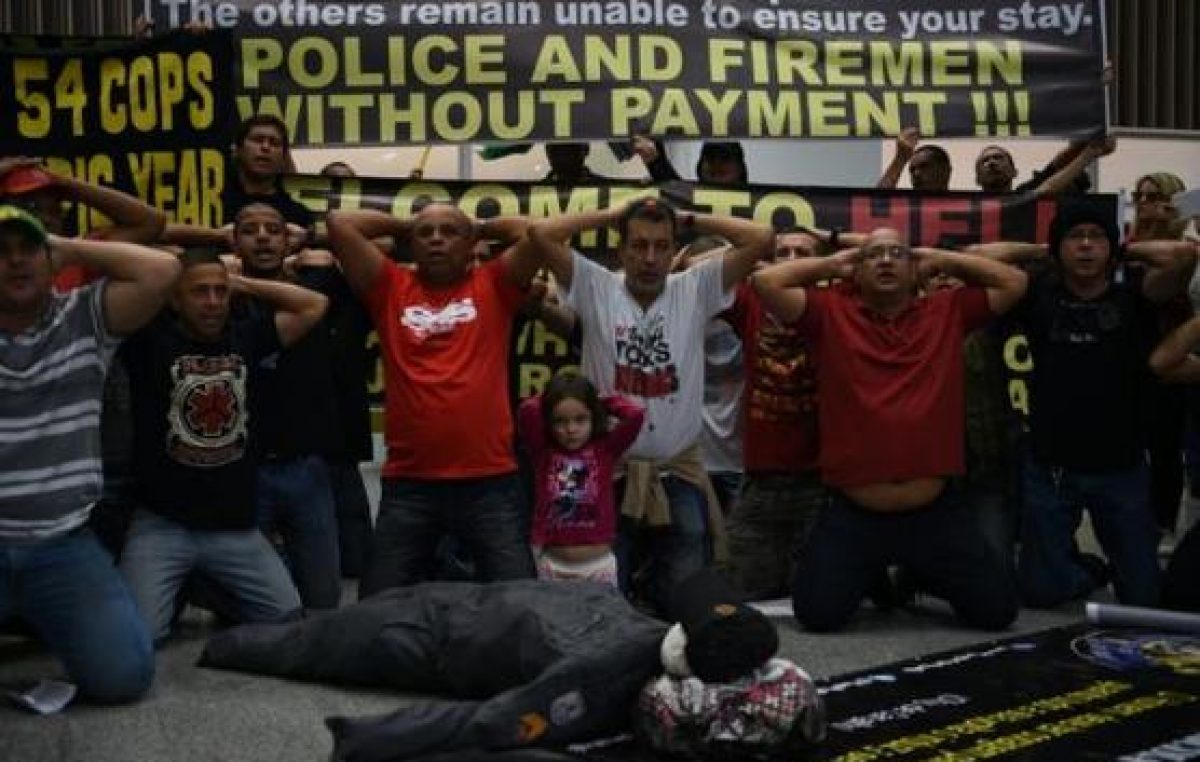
{"left": 258, "top": 455, "right": 342, "bottom": 608}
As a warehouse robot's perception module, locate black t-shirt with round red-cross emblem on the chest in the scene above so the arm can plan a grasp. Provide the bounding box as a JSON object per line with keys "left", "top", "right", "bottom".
{"left": 122, "top": 310, "right": 280, "bottom": 530}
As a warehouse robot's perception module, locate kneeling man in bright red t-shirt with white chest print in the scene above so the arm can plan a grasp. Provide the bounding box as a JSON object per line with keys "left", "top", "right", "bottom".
{"left": 328, "top": 204, "right": 540, "bottom": 596}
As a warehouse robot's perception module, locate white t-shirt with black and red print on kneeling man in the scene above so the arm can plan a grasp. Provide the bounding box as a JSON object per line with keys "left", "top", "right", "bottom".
{"left": 566, "top": 253, "right": 733, "bottom": 460}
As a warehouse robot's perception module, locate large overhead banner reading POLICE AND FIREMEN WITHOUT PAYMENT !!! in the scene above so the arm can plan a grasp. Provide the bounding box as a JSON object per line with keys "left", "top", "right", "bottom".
{"left": 132, "top": 0, "right": 1106, "bottom": 145}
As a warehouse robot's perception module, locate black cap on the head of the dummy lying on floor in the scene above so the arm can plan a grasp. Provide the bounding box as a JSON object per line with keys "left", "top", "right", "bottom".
{"left": 671, "top": 569, "right": 779, "bottom": 683}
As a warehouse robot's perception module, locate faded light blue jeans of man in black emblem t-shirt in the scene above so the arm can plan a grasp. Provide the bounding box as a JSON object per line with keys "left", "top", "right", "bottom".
{"left": 121, "top": 510, "right": 300, "bottom": 643}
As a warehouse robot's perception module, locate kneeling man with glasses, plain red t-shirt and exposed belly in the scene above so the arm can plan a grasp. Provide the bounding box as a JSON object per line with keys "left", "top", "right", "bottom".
{"left": 751, "top": 228, "right": 1026, "bottom": 631}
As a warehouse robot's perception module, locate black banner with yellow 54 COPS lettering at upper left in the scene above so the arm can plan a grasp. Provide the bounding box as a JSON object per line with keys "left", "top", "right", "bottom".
{"left": 0, "top": 32, "right": 236, "bottom": 229}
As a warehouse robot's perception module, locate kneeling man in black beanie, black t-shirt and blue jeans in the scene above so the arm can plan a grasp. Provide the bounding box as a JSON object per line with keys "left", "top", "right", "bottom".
{"left": 1014, "top": 200, "right": 1195, "bottom": 606}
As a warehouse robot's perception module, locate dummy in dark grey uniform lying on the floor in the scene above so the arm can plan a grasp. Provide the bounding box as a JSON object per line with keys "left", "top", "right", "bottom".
{"left": 200, "top": 576, "right": 824, "bottom": 762}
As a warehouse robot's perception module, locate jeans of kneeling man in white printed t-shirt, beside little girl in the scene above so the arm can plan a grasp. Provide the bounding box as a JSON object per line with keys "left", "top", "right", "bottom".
{"left": 613, "top": 476, "right": 712, "bottom": 613}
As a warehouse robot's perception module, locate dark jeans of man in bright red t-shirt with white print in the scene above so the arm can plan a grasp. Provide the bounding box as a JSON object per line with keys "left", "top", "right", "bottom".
{"left": 359, "top": 474, "right": 535, "bottom": 598}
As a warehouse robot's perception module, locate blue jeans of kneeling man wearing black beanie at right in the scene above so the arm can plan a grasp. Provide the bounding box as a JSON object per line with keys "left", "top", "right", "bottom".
{"left": 1016, "top": 456, "right": 1160, "bottom": 606}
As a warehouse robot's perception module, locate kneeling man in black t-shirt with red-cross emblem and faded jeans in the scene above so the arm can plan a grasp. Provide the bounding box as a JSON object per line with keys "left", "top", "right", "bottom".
{"left": 121, "top": 250, "right": 326, "bottom": 642}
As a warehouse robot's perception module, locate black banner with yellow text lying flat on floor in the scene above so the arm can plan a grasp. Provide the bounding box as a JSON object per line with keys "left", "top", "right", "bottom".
{"left": 814, "top": 625, "right": 1200, "bottom": 762}
